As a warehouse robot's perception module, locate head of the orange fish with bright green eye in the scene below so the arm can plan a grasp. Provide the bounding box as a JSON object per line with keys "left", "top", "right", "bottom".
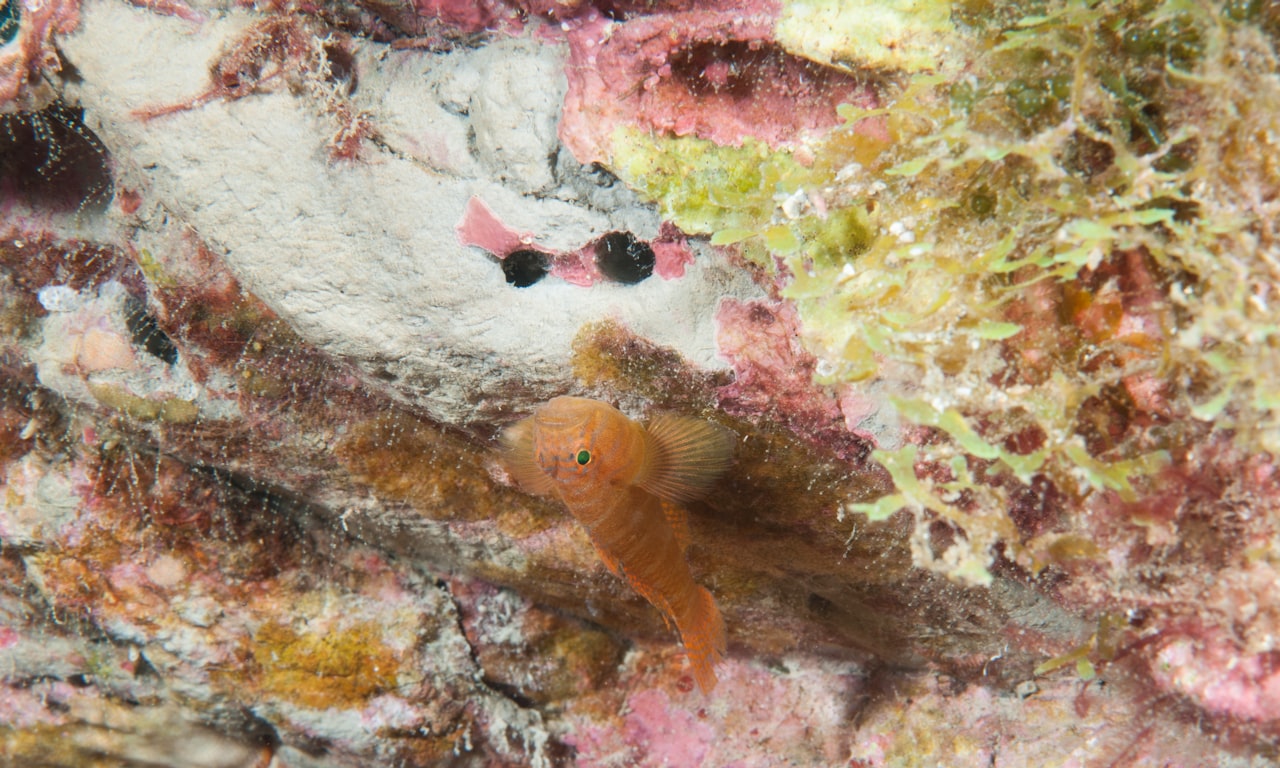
{"left": 534, "top": 397, "right": 644, "bottom": 488}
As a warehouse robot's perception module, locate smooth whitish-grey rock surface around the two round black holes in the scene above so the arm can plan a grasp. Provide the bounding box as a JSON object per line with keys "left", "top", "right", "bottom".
{"left": 64, "top": 0, "right": 759, "bottom": 424}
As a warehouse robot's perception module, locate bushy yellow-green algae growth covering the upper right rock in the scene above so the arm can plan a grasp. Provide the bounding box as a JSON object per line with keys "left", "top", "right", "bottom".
{"left": 601, "top": 0, "right": 1280, "bottom": 584}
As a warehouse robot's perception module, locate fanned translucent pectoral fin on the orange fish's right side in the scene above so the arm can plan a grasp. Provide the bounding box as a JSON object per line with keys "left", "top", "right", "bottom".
{"left": 637, "top": 416, "right": 733, "bottom": 502}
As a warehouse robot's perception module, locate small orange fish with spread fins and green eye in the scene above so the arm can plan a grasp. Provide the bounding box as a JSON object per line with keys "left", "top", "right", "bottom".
{"left": 502, "top": 397, "right": 733, "bottom": 691}
